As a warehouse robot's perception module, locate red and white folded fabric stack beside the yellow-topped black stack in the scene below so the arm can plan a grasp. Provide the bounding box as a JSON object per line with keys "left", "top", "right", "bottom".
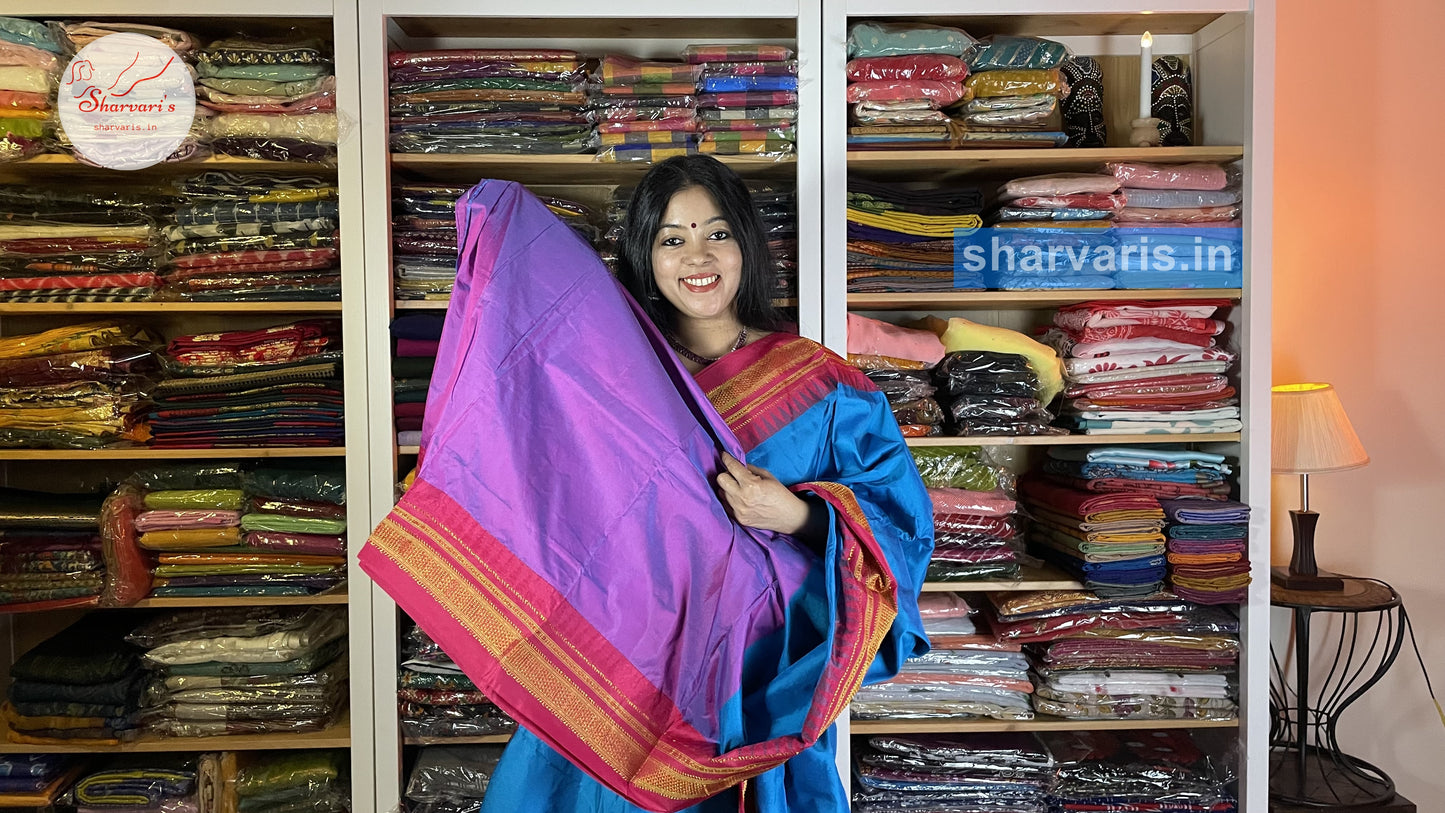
{"left": 1043, "top": 300, "right": 1243, "bottom": 435}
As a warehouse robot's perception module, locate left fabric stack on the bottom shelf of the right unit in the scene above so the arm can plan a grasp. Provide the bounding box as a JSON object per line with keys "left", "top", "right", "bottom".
{"left": 853, "top": 732, "right": 1053, "bottom": 813}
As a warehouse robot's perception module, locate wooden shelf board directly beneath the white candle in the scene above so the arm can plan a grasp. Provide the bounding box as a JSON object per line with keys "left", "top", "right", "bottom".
{"left": 848, "top": 146, "right": 1244, "bottom": 179}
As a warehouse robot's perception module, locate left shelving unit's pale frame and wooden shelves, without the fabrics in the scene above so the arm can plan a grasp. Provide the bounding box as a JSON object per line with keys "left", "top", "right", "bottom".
{"left": 0, "top": 0, "right": 374, "bottom": 813}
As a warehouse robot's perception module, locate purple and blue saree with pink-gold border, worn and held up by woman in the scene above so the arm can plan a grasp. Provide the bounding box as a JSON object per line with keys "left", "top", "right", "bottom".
{"left": 360, "top": 181, "right": 932, "bottom": 812}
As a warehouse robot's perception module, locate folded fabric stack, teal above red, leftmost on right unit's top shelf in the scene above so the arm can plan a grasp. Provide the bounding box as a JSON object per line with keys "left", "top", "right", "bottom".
{"left": 847, "top": 22, "right": 975, "bottom": 150}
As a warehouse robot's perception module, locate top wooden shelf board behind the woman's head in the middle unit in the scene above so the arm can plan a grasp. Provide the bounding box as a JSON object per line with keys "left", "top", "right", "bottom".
{"left": 392, "top": 153, "right": 796, "bottom": 185}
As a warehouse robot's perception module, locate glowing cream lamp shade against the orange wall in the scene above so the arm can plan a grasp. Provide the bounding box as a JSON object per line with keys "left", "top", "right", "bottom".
{"left": 1270, "top": 384, "right": 1370, "bottom": 474}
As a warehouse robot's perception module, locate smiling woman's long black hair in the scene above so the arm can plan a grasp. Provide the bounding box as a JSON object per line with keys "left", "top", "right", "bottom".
{"left": 617, "top": 155, "right": 777, "bottom": 331}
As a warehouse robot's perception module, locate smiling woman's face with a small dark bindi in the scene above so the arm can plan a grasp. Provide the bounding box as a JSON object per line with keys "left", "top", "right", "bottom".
{"left": 652, "top": 186, "right": 743, "bottom": 326}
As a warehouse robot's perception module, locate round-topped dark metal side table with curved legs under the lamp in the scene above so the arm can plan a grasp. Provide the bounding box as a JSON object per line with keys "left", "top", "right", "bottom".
{"left": 1269, "top": 576, "right": 1405, "bottom": 809}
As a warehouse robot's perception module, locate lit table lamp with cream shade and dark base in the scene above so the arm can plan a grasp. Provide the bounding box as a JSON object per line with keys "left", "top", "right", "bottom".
{"left": 1270, "top": 384, "right": 1370, "bottom": 591}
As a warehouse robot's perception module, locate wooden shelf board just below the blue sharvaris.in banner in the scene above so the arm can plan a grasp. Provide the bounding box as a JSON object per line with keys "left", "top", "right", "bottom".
{"left": 848, "top": 287, "right": 1240, "bottom": 310}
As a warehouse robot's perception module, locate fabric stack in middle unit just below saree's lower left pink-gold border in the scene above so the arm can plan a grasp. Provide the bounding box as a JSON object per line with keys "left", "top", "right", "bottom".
{"left": 396, "top": 627, "right": 516, "bottom": 736}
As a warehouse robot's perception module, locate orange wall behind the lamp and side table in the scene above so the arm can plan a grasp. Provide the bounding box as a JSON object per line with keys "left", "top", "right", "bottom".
{"left": 1273, "top": 0, "right": 1445, "bottom": 812}
